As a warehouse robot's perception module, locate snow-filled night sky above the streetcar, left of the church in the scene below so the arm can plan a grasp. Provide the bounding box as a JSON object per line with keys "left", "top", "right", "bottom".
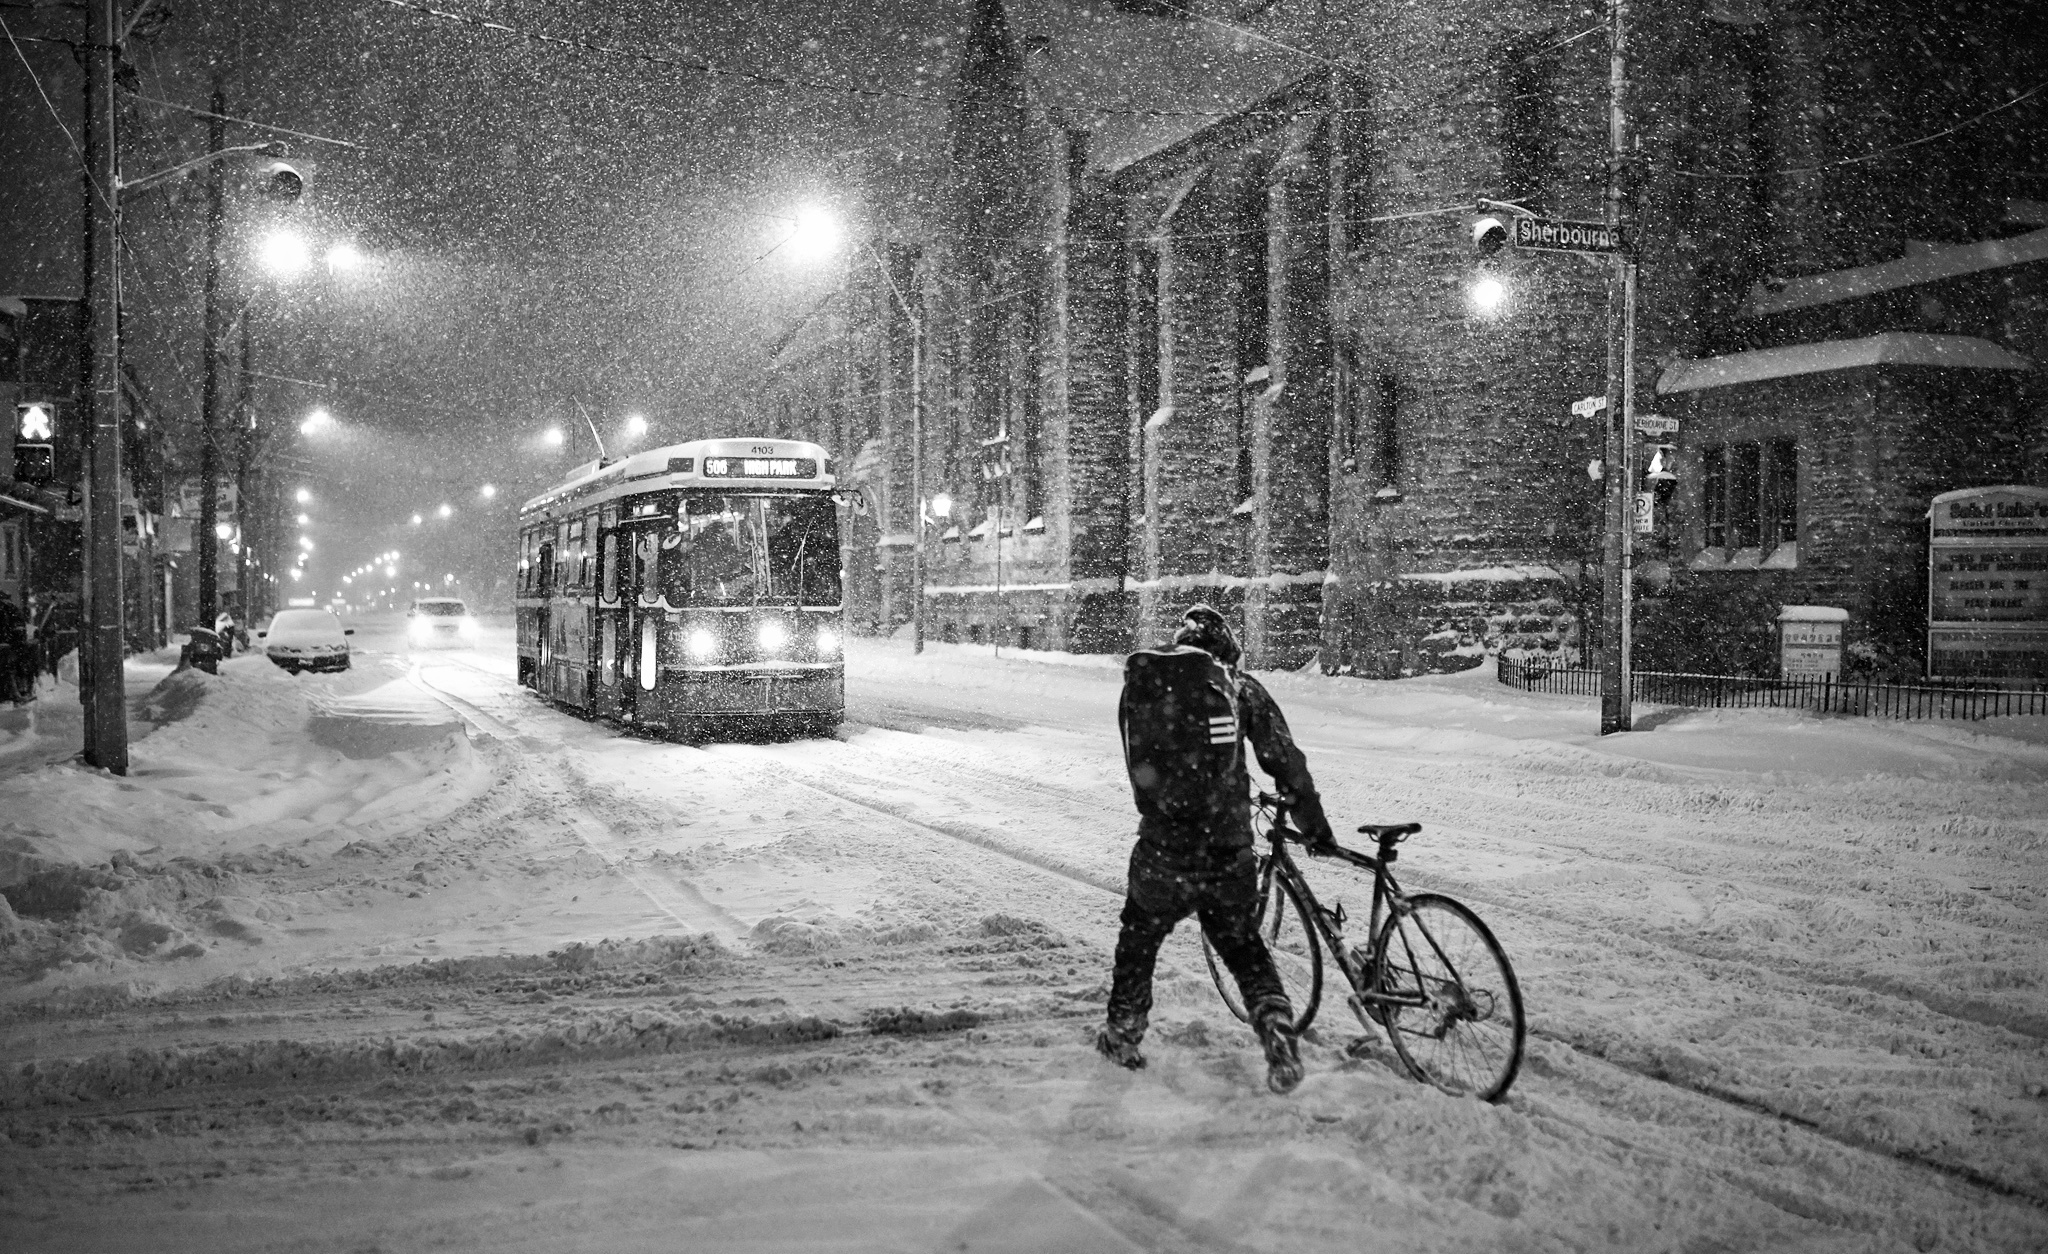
{"left": 0, "top": 0, "right": 967, "bottom": 578}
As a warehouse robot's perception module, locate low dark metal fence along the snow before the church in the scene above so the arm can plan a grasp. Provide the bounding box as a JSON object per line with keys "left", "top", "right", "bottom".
{"left": 1497, "top": 658, "right": 2048, "bottom": 719}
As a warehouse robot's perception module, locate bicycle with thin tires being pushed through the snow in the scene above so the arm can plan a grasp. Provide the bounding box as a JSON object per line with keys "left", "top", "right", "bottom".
{"left": 1202, "top": 793, "right": 1528, "bottom": 1102}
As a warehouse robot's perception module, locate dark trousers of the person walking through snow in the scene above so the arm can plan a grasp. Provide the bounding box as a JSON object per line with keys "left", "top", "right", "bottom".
{"left": 1110, "top": 842, "right": 1294, "bottom": 1039}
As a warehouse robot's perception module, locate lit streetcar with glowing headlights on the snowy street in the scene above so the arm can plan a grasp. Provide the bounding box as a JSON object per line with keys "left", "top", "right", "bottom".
{"left": 518, "top": 441, "right": 846, "bottom": 740}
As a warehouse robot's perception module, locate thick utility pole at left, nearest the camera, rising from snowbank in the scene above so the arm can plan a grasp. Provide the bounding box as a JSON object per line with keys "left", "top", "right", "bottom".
{"left": 78, "top": 0, "right": 127, "bottom": 775}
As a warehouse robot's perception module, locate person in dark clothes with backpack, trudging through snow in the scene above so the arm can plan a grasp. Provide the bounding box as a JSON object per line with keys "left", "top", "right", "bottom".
{"left": 1096, "top": 604, "right": 1335, "bottom": 1092}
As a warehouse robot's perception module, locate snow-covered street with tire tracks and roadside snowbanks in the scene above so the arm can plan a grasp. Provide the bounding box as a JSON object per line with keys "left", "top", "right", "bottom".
{"left": 0, "top": 625, "right": 2048, "bottom": 1250}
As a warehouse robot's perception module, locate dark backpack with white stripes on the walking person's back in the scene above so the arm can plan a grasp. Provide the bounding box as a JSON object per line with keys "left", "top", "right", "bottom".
{"left": 1118, "top": 650, "right": 1245, "bottom": 824}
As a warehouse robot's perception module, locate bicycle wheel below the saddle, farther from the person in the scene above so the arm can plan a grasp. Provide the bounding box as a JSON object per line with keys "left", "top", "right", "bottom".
{"left": 1374, "top": 893, "right": 1528, "bottom": 1102}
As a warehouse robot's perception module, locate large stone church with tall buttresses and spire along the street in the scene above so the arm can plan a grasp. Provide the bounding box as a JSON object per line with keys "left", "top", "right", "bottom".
{"left": 772, "top": 0, "right": 2048, "bottom": 676}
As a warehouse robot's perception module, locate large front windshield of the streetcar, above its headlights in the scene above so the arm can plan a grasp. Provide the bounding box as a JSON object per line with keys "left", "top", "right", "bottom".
{"left": 662, "top": 492, "right": 840, "bottom": 607}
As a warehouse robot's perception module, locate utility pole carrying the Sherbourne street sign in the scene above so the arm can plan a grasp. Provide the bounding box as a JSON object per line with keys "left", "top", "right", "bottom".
{"left": 1599, "top": 0, "right": 1636, "bottom": 736}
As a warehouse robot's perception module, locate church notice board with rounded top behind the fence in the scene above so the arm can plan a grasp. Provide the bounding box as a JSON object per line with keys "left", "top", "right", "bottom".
{"left": 1927, "top": 486, "right": 2048, "bottom": 680}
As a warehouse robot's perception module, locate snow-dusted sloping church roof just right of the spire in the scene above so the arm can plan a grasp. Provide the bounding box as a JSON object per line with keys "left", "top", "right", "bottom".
{"left": 1006, "top": 0, "right": 1329, "bottom": 172}
